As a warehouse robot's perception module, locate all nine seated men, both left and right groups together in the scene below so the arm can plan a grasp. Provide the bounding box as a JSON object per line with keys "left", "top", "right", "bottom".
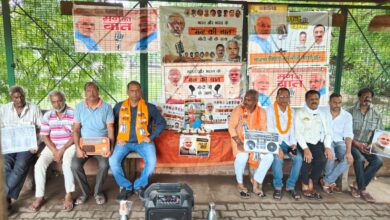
{"left": 0, "top": 81, "right": 383, "bottom": 215}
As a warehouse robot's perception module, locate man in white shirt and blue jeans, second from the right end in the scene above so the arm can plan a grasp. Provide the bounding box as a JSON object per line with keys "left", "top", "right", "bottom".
{"left": 321, "top": 93, "right": 353, "bottom": 193}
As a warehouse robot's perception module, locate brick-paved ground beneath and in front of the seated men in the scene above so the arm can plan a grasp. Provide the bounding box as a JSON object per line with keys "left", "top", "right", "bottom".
{"left": 9, "top": 175, "right": 390, "bottom": 220}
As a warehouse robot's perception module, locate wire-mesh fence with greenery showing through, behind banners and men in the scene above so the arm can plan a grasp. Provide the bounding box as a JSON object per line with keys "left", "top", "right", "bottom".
{"left": 0, "top": 0, "right": 390, "bottom": 129}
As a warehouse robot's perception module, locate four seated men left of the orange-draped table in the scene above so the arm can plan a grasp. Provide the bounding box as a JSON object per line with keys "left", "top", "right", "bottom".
{"left": 0, "top": 81, "right": 166, "bottom": 212}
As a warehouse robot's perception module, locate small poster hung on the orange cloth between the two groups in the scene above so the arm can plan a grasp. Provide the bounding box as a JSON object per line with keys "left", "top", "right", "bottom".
{"left": 179, "top": 135, "right": 210, "bottom": 157}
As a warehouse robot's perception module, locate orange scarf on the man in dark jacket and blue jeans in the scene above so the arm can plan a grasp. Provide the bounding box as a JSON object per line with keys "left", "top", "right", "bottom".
{"left": 117, "top": 99, "right": 149, "bottom": 144}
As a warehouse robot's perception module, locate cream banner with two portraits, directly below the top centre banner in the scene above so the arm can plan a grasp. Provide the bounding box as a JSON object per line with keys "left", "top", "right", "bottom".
{"left": 164, "top": 64, "right": 243, "bottom": 104}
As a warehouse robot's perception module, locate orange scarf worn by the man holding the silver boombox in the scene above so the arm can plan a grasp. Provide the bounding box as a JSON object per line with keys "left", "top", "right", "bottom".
{"left": 240, "top": 106, "right": 260, "bottom": 169}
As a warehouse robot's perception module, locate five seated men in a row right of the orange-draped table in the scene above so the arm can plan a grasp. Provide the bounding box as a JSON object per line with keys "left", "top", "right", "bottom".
{"left": 228, "top": 88, "right": 383, "bottom": 202}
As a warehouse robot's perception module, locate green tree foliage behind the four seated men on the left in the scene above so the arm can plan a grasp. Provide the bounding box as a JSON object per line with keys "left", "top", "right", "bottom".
{"left": 8, "top": 0, "right": 123, "bottom": 106}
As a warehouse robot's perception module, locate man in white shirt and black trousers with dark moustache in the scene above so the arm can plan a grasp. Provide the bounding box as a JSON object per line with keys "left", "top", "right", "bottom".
{"left": 295, "top": 90, "right": 332, "bottom": 200}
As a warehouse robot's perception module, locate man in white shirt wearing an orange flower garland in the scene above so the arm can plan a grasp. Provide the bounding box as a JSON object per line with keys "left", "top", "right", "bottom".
{"left": 267, "top": 88, "right": 302, "bottom": 200}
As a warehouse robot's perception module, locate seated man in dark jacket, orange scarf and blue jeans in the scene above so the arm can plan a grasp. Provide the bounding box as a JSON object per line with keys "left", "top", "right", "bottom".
{"left": 109, "top": 81, "right": 166, "bottom": 201}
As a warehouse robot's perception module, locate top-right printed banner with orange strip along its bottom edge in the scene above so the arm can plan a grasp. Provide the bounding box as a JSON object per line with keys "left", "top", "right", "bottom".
{"left": 248, "top": 12, "right": 331, "bottom": 67}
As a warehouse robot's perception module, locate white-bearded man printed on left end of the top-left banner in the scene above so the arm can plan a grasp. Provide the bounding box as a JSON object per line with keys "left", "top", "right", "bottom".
{"left": 74, "top": 16, "right": 102, "bottom": 52}
